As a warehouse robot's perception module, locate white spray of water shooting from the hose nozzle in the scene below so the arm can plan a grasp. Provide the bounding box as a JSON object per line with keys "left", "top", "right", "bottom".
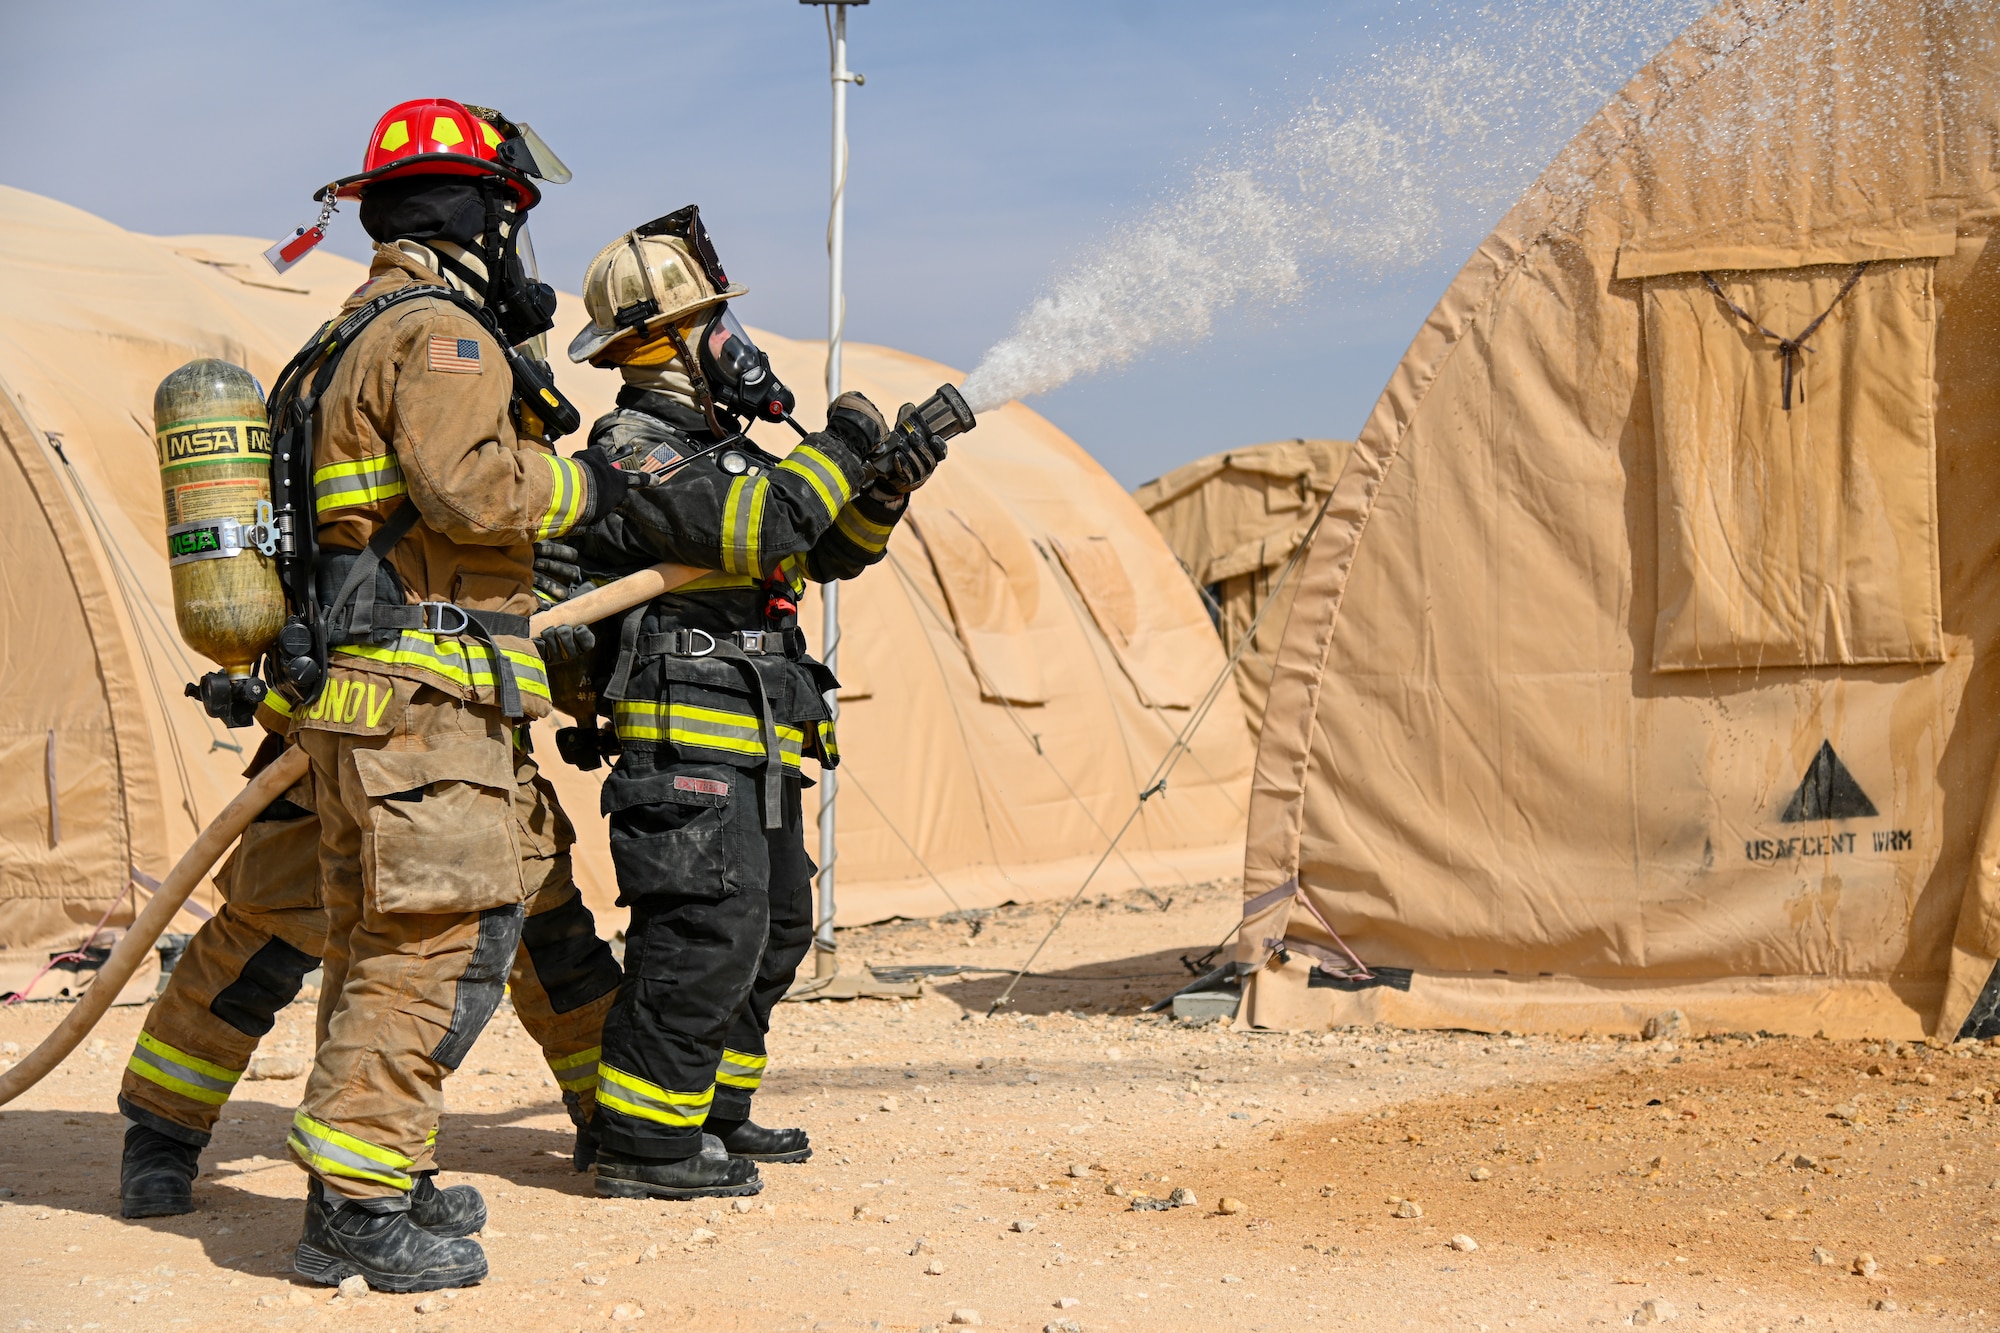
{"left": 964, "top": 0, "right": 1708, "bottom": 410}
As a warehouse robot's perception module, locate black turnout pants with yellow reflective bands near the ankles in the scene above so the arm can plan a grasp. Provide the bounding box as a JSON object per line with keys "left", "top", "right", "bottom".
{"left": 598, "top": 751, "right": 816, "bottom": 1161}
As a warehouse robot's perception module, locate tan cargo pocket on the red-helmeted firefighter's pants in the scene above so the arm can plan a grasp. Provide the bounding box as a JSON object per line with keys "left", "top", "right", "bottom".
{"left": 354, "top": 745, "right": 524, "bottom": 913}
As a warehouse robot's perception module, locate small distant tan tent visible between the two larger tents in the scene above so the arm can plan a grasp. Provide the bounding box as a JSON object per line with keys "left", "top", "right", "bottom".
{"left": 1132, "top": 440, "right": 1352, "bottom": 737}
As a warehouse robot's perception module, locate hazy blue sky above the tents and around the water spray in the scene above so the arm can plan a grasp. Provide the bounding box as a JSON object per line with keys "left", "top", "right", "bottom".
{"left": 0, "top": 0, "right": 1700, "bottom": 484}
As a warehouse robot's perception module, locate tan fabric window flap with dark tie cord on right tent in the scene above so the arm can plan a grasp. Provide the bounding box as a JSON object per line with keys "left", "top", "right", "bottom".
{"left": 1644, "top": 258, "right": 1944, "bottom": 671}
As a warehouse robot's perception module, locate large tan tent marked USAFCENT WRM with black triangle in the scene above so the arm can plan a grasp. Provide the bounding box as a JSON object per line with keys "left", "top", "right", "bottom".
{"left": 1238, "top": 0, "right": 2000, "bottom": 1037}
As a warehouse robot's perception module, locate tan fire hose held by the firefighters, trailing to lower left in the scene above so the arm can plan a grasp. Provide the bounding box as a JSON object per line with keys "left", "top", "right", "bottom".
{"left": 0, "top": 564, "right": 708, "bottom": 1105}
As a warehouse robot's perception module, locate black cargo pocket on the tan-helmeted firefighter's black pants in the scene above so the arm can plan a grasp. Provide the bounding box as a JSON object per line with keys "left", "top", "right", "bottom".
{"left": 602, "top": 765, "right": 764, "bottom": 905}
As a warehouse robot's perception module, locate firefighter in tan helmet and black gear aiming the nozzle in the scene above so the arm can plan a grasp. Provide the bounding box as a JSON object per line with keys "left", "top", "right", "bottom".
{"left": 536, "top": 208, "right": 944, "bottom": 1199}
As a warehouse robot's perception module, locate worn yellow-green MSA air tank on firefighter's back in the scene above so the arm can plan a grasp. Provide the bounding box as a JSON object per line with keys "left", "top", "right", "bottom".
{"left": 152, "top": 358, "right": 284, "bottom": 680}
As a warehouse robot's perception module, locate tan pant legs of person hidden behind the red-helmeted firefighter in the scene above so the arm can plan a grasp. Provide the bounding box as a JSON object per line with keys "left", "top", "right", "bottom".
{"left": 118, "top": 736, "right": 620, "bottom": 1147}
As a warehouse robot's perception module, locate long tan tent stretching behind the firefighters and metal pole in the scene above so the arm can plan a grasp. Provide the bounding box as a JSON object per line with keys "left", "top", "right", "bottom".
{"left": 0, "top": 188, "right": 1250, "bottom": 995}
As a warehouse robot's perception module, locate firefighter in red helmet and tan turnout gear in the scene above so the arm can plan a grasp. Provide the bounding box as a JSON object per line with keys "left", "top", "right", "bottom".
{"left": 247, "top": 98, "right": 626, "bottom": 1291}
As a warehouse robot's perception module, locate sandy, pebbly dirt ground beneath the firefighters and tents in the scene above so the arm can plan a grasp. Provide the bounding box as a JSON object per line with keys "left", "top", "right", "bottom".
{"left": 0, "top": 872, "right": 2000, "bottom": 1333}
